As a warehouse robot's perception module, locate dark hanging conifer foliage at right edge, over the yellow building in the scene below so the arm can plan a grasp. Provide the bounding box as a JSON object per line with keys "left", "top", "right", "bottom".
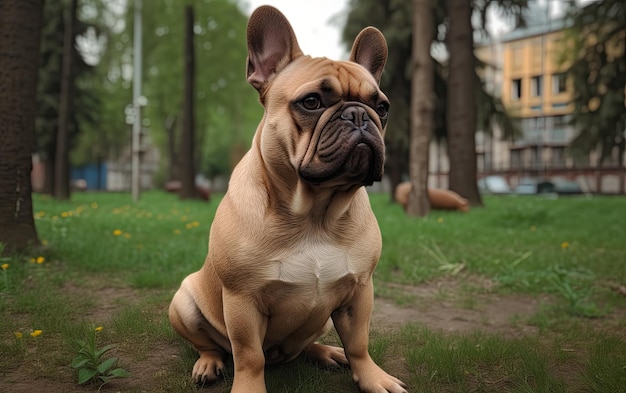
{"left": 564, "top": 0, "right": 626, "bottom": 163}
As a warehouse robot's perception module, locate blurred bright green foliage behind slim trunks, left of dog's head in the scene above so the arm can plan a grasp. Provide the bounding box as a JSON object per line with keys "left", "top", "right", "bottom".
{"left": 99, "top": 0, "right": 262, "bottom": 177}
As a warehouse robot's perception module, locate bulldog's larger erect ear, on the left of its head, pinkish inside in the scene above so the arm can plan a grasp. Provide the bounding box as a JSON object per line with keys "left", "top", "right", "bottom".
{"left": 246, "top": 5, "right": 302, "bottom": 92}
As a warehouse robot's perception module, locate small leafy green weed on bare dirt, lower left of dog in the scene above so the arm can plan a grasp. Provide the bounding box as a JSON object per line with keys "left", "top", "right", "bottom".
{"left": 72, "top": 327, "right": 130, "bottom": 385}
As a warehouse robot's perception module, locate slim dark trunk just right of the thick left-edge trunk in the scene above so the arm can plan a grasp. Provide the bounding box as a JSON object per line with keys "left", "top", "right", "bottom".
{"left": 54, "top": 0, "right": 77, "bottom": 200}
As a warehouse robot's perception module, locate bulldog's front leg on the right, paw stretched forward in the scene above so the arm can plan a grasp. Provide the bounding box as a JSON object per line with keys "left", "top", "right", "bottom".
{"left": 332, "top": 279, "right": 407, "bottom": 393}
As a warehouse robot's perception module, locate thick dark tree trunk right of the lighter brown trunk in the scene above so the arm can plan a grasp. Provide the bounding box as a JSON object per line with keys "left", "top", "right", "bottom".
{"left": 446, "top": 0, "right": 482, "bottom": 206}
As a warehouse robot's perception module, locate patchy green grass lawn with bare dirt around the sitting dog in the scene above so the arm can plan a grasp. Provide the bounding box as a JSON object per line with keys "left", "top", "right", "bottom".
{"left": 0, "top": 192, "right": 626, "bottom": 393}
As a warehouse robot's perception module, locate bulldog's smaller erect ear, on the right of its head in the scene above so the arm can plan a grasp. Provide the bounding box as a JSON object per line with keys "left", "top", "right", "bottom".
{"left": 350, "top": 26, "right": 387, "bottom": 83}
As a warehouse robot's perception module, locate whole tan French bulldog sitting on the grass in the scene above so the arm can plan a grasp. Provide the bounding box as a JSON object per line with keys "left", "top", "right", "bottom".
{"left": 169, "top": 6, "right": 406, "bottom": 393}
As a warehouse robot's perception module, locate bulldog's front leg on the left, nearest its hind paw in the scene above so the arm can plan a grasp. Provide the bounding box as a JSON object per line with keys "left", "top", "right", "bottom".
{"left": 223, "top": 289, "right": 267, "bottom": 393}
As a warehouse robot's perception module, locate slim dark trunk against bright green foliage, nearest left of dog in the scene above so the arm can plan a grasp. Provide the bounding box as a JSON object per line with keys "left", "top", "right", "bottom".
{"left": 179, "top": 5, "right": 198, "bottom": 199}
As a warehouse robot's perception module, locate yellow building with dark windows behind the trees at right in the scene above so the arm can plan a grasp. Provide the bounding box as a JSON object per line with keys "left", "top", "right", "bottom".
{"left": 494, "top": 17, "right": 575, "bottom": 171}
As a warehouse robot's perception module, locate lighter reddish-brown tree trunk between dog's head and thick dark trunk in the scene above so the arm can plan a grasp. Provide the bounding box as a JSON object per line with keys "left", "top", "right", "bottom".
{"left": 406, "top": 0, "right": 435, "bottom": 217}
